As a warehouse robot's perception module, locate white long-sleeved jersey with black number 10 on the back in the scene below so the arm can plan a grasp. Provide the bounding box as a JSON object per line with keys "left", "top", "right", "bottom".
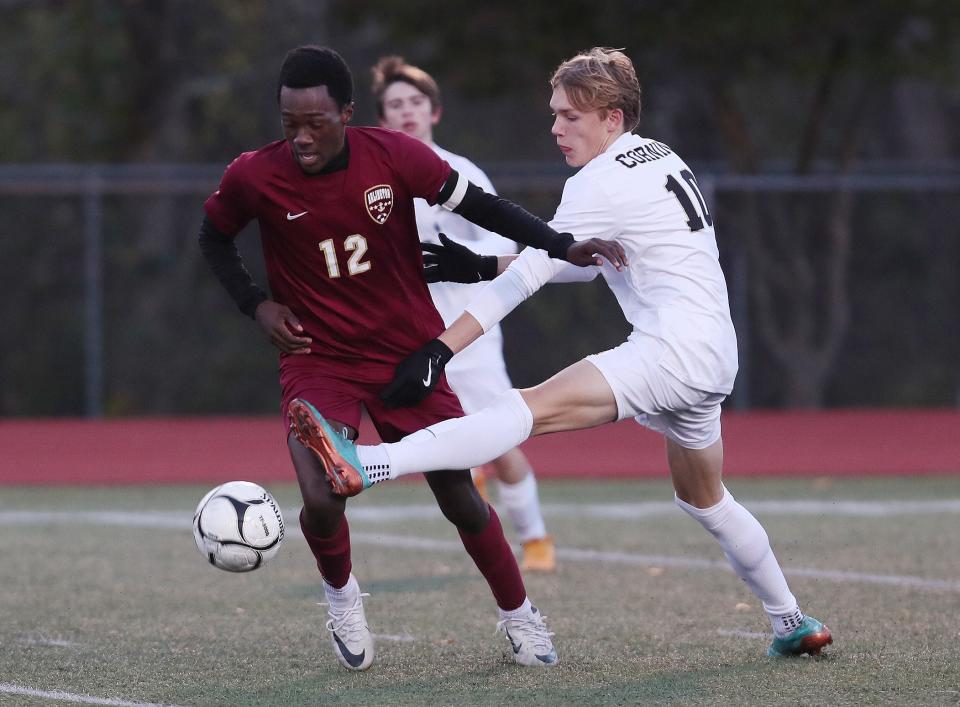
{"left": 467, "top": 133, "right": 737, "bottom": 394}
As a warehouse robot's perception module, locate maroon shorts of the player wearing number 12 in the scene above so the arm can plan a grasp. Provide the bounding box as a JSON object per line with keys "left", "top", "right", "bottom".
{"left": 280, "top": 356, "right": 463, "bottom": 442}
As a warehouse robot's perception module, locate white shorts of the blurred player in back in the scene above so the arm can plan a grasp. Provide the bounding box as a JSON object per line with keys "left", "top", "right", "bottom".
{"left": 444, "top": 327, "right": 513, "bottom": 414}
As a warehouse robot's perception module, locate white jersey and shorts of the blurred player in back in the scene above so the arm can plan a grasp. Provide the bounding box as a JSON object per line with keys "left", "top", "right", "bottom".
{"left": 413, "top": 145, "right": 517, "bottom": 404}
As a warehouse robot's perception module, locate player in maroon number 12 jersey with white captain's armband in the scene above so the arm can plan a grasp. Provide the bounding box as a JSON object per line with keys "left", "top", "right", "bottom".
{"left": 200, "top": 46, "right": 624, "bottom": 670}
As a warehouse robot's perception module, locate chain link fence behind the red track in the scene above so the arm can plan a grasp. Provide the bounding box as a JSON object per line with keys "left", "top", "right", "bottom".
{"left": 0, "top": 163, "right": 960, "bottom": 417}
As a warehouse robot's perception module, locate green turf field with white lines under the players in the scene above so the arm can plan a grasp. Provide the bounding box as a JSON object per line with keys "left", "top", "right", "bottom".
{"left": 0, "top": 477, "right": 960, "bottom": 706}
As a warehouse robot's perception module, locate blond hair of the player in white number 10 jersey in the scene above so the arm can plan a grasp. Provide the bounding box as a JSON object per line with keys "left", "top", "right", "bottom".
{"left": 550, "top": 47, "right": 640, "bottom": 132}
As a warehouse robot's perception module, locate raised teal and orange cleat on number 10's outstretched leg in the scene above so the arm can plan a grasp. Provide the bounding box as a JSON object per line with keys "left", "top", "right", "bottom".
{"left": 287, "top": 398, "right": 373, "bottom": 496}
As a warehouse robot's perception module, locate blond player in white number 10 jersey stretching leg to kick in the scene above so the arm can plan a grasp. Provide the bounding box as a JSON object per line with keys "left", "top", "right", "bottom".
{"left": 294, "top": 48, "right": 832, "bottom": 656}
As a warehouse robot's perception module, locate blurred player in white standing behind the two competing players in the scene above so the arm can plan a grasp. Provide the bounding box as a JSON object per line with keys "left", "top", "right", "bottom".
{"left": 371, "top": 56, "right": 556, "bottom": 572}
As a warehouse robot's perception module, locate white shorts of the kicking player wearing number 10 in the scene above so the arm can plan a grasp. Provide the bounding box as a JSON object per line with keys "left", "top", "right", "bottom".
{"left": 586, "top": 334, "right": 727, "bottom": 449}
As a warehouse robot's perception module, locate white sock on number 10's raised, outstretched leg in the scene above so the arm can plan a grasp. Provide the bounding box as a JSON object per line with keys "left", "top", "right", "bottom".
{"left": 357, "top": 390, "right": 533, "bottom": 480}
